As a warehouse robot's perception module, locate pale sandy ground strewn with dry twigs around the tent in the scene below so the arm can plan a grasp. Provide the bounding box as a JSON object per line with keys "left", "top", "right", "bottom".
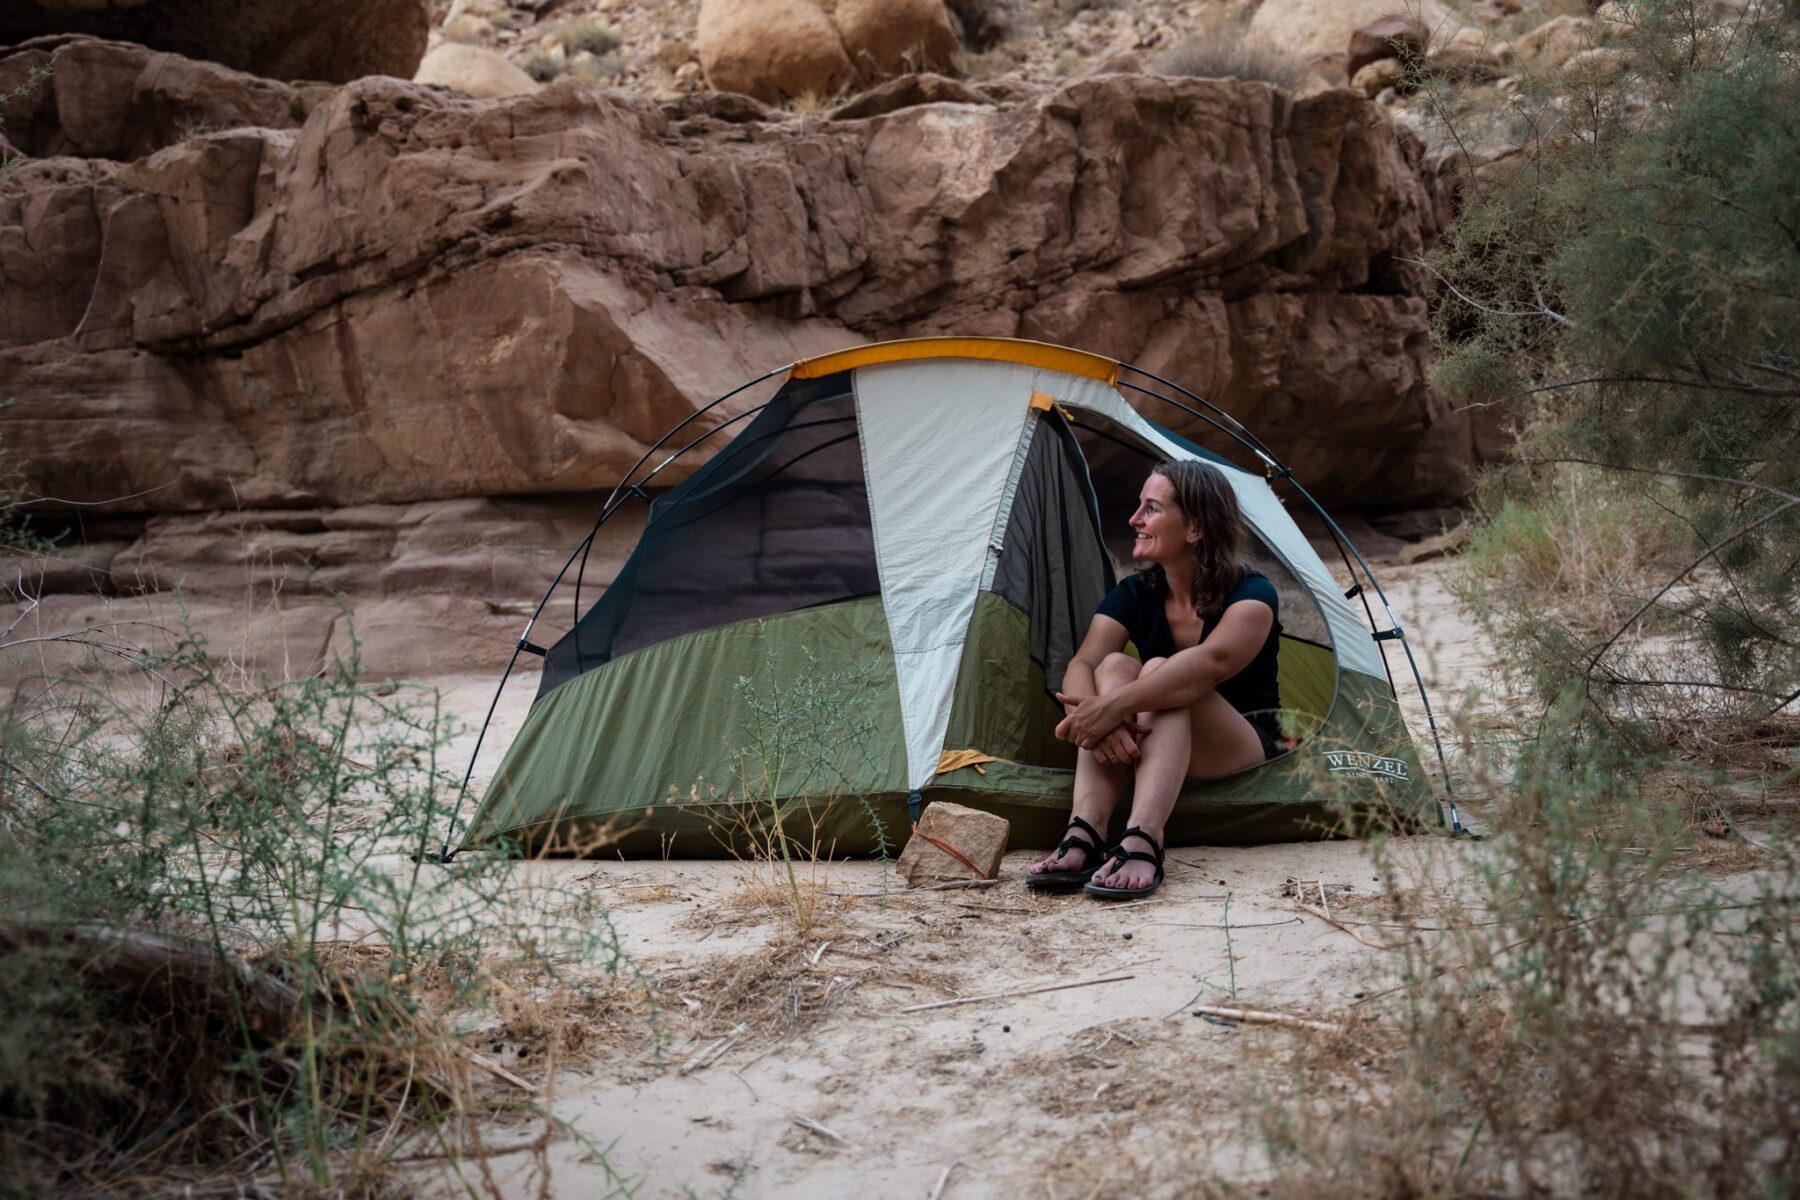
{"left": 397, "top": 565, "right": 1490, "bottom": 1200}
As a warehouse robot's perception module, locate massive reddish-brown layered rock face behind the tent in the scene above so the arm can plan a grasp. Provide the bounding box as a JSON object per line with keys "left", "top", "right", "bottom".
{"left": 0, "top": 41, "right": 1469, "bottom": 511}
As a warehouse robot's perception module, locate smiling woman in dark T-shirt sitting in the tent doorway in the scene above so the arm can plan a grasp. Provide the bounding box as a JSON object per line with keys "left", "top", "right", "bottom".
{"left": 1026, "top": 462, "right": 1283, "bottom": 900}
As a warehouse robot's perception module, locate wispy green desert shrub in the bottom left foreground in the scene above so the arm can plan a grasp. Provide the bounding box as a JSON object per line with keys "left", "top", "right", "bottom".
{"left": 0, "top": 618, "right": 623, "bottom": 1195}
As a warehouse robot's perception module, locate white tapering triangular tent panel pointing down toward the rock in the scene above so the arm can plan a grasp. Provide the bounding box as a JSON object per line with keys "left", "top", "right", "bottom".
{"left": 855, "top": 360, "right": 1044, "bottom": 790}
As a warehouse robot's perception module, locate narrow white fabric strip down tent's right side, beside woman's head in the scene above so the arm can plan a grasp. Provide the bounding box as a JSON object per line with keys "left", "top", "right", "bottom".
{"left": 1057, "top": 376, "right": 1388, "bottom": 680}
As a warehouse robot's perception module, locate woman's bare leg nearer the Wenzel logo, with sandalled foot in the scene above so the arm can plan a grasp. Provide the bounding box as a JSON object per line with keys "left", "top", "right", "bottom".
{"left": 1094, "top": 658, "right": 1264, "bottom": 887}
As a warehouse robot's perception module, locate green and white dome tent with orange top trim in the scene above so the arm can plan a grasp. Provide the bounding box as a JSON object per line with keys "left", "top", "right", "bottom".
{"left": 445, "top": 338, "right": 1454, "bottom": 856}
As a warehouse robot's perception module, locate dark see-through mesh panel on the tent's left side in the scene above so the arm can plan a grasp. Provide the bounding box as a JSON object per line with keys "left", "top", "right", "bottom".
{"left": 538, "top": 372, "right": 880, "bottom": 696}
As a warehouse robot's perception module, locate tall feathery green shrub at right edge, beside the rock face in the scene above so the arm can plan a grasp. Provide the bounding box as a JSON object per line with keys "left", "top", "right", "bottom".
{"left": 1431, "top": 0, "right": 1800, "bottom": 745}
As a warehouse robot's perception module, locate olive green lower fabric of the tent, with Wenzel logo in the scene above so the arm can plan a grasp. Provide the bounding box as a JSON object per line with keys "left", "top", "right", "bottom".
{"left": 473, "top": 594, "right": 1431, "bottom": 858}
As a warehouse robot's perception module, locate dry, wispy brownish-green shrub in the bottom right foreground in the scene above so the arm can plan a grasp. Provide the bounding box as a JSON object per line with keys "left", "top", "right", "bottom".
{"left": 1255, "top": 705, "right": 1800, "bottom": 1196}
